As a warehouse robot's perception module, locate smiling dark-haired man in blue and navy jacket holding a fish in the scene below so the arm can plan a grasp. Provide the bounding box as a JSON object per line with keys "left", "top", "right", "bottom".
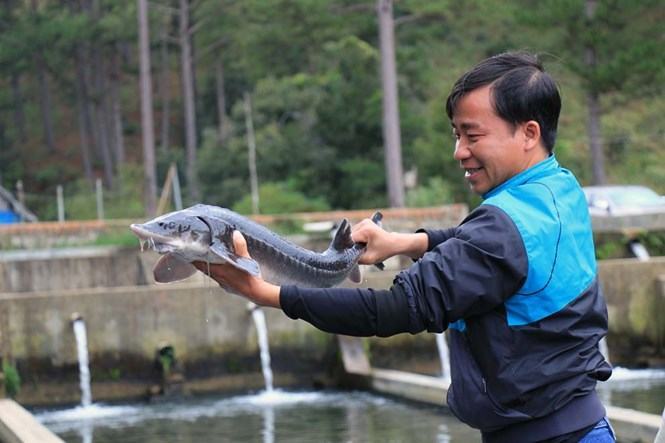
{"left": 195, "top": 53, "right": 614, "bottom": 442}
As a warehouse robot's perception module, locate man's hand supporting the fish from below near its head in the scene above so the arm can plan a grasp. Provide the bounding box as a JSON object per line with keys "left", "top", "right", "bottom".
{"left": 192, "top": 231, "right": 280, "bottom": 308}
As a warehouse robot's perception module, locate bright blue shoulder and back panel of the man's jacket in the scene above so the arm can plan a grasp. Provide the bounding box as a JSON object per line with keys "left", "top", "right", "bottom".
{"left": 483, "top": 156, "right": 596, "bottom": 326}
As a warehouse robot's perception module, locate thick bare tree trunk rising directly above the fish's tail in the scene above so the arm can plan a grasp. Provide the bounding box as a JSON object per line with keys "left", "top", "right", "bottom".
{"left": 376, "top": 0, "right": 404, "bottom": 207}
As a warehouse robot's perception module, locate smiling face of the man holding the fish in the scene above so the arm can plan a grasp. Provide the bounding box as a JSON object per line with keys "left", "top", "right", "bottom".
{"left": 452, "top": 86, "right": 546, "bottom": 195}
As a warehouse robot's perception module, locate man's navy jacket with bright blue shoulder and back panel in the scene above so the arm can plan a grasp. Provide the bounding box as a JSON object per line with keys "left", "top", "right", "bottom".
{"left": 280, "top": 157, "right": 611, "bottom": 441}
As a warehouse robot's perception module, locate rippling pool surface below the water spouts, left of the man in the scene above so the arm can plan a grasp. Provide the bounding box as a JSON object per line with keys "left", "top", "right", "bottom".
{"left": 36, "top": 390, "right": 480, "bottom": 443}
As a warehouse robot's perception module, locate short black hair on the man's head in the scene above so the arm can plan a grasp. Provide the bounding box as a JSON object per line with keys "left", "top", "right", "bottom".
{"left": 446, "top": 52, "right": 561, "bottom": 152}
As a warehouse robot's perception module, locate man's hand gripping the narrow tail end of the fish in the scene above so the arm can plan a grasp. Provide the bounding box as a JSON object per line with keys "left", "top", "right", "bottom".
{"left": 351, "top": 219, "right": 428, "bottom": 265}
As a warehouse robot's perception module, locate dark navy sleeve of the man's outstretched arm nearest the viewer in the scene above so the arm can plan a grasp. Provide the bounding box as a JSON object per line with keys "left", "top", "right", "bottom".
{"left": 280, "top": 206, "right": 527, "bottom": 337}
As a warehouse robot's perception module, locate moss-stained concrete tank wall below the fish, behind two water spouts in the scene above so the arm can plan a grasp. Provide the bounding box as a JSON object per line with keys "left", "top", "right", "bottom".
{"left": 0, "top": 284, "right": 333, "bottom": 404}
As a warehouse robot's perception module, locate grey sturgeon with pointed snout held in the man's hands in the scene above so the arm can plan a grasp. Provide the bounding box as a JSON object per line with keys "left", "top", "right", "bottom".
{"left": 129, "top": 204, "right": 383, "bottom": 289}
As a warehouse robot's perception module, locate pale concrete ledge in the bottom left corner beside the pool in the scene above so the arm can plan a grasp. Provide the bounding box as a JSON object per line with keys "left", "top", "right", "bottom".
{"left": 0, "top": 399, "right": 65, "bottom": 443}
